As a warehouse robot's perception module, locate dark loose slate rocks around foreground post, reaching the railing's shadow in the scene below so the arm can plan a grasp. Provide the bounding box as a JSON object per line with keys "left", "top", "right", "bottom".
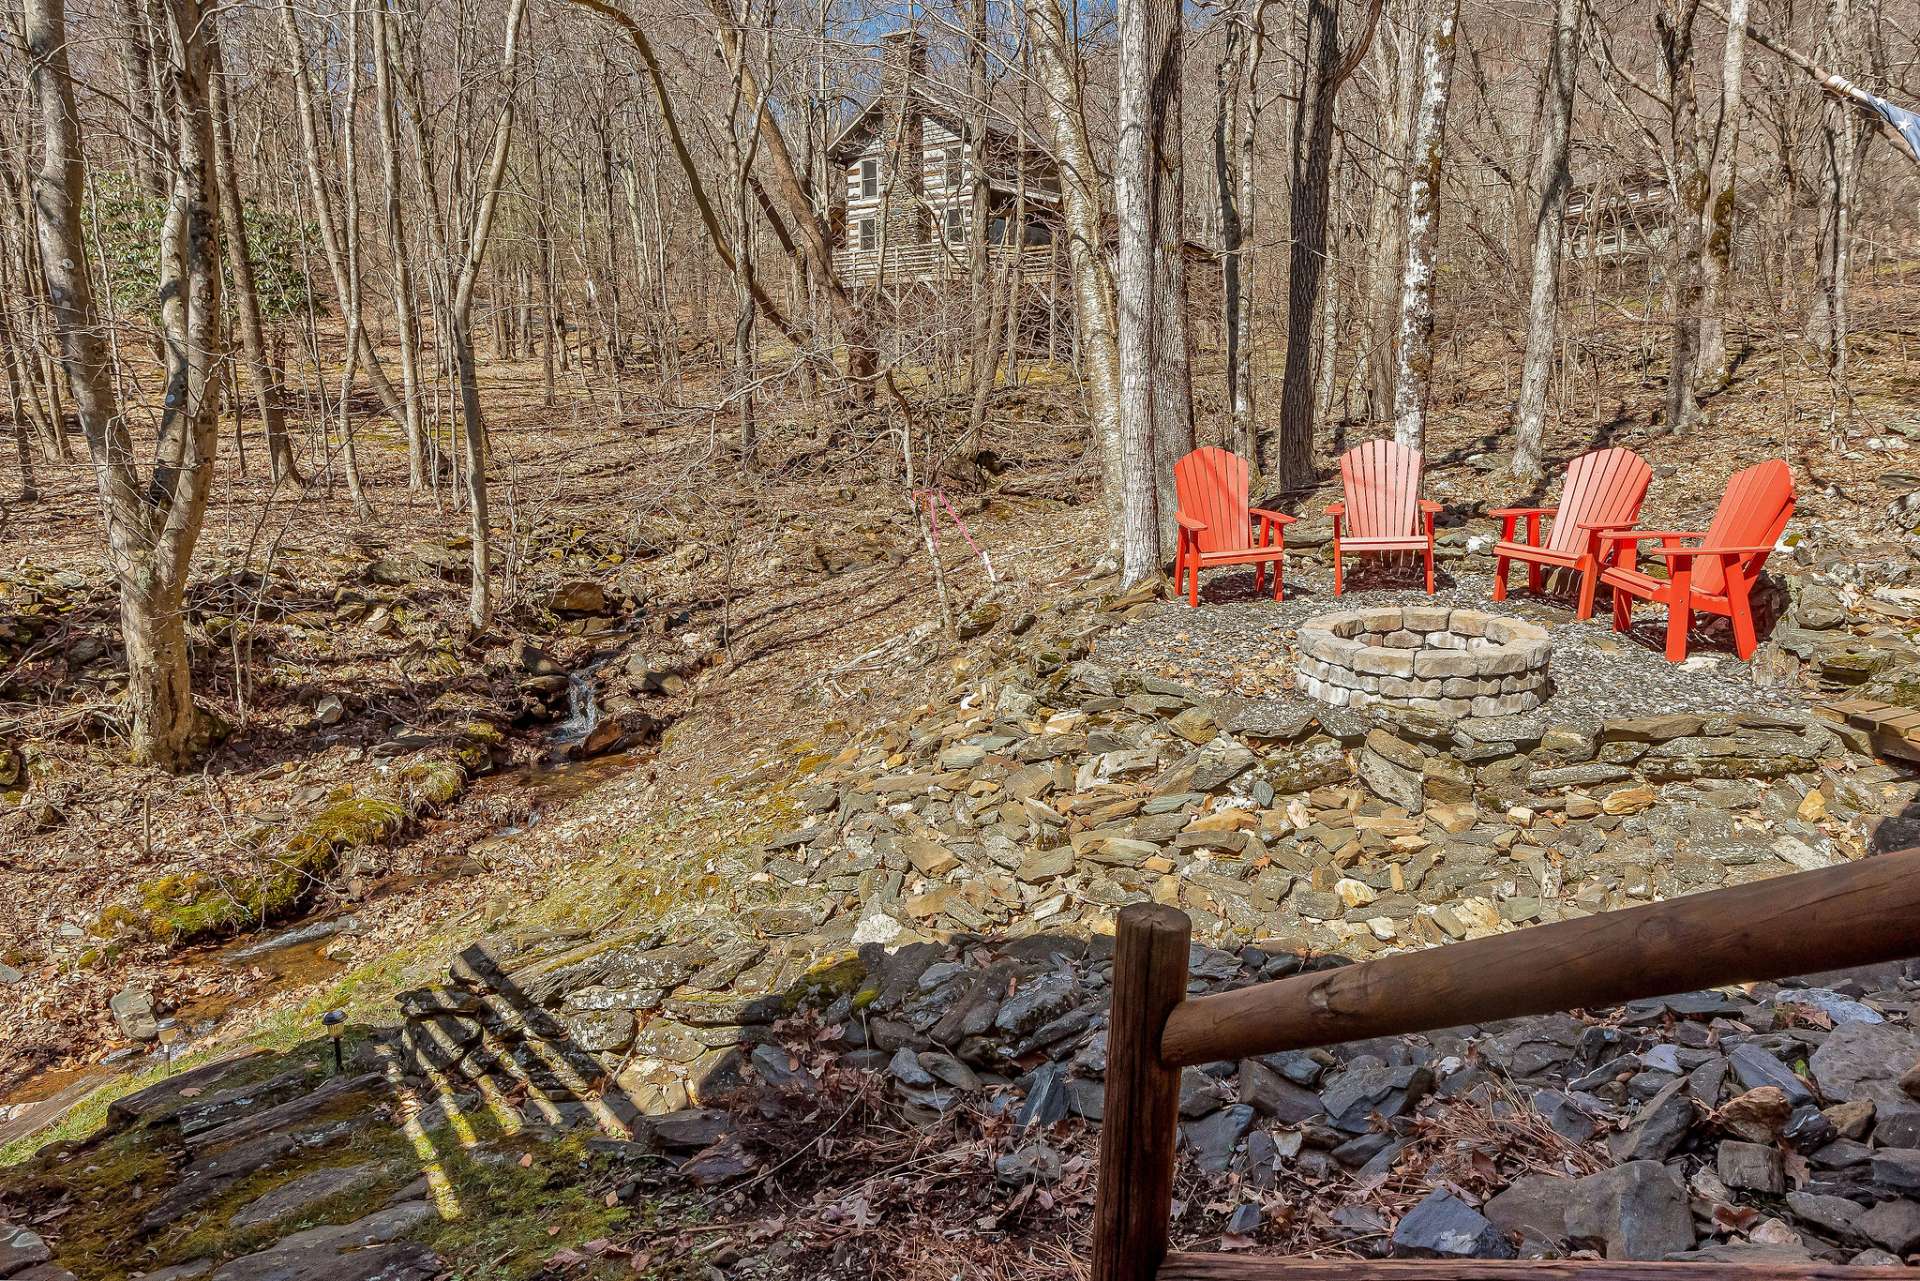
{"left": 385, "top": 910, "right": 1920, "bottom": 1264}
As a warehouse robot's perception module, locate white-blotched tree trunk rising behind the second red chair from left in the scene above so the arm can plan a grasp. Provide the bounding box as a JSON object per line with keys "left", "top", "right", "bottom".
{"left": 1394, "top": 0, "right": 1459, "bottom": 449}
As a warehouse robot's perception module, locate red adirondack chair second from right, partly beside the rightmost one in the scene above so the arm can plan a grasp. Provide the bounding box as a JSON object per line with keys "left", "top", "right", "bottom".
{"left": 1486, "top": 447, "right": 1653, "bottom": 618}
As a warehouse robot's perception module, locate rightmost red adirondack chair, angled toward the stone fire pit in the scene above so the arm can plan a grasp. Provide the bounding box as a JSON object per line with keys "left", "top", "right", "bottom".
{"left": 1599, "top": 459, "right": 1793, "bottom": 663}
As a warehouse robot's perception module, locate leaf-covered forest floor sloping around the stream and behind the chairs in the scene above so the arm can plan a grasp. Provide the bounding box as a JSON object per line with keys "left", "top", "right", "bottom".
{"left": 0, "top": 280, "right": 1920, "bottom": 1277}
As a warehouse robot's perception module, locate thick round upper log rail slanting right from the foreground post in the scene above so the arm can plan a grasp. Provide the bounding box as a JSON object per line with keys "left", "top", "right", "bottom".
{"left": 1160, "top": 849, "right": 1920, "bottom": 1068}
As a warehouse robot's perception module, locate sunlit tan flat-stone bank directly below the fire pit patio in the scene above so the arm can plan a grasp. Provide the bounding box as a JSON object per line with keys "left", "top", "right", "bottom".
{"left": 710, "top": 637, "right": 1873, "bottom": 953}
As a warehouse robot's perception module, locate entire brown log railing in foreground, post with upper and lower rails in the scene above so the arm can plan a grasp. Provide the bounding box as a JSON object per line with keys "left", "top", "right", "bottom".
{"left": 1092, "top": 849, "right": 1920, "bottom": 1281}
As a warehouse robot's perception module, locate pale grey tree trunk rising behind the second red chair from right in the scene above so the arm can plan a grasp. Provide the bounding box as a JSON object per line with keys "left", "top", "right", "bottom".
{"left": 1513, "top": 0, "right": 1582, "bottom": 482}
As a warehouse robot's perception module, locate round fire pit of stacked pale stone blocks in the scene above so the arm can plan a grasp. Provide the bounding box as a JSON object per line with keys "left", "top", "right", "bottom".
{"left": 1294, "top": 605, "right": 1551, "bottom": 716}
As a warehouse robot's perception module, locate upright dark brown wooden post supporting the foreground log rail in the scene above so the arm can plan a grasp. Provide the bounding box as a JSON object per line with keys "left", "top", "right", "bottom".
{"left": 1092, "top": 903, "right": 1192, "bottom": 1281}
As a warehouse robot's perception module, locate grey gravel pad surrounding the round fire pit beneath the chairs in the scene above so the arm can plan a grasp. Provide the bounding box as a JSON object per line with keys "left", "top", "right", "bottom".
{"left": 1092, "top": 567, "right": 1795, "bottom": 728}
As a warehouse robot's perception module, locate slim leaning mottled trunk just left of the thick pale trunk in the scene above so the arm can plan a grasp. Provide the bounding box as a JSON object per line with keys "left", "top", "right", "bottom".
{"left": 1027, "top": 0, "right": 1127, "bottom": 567}
